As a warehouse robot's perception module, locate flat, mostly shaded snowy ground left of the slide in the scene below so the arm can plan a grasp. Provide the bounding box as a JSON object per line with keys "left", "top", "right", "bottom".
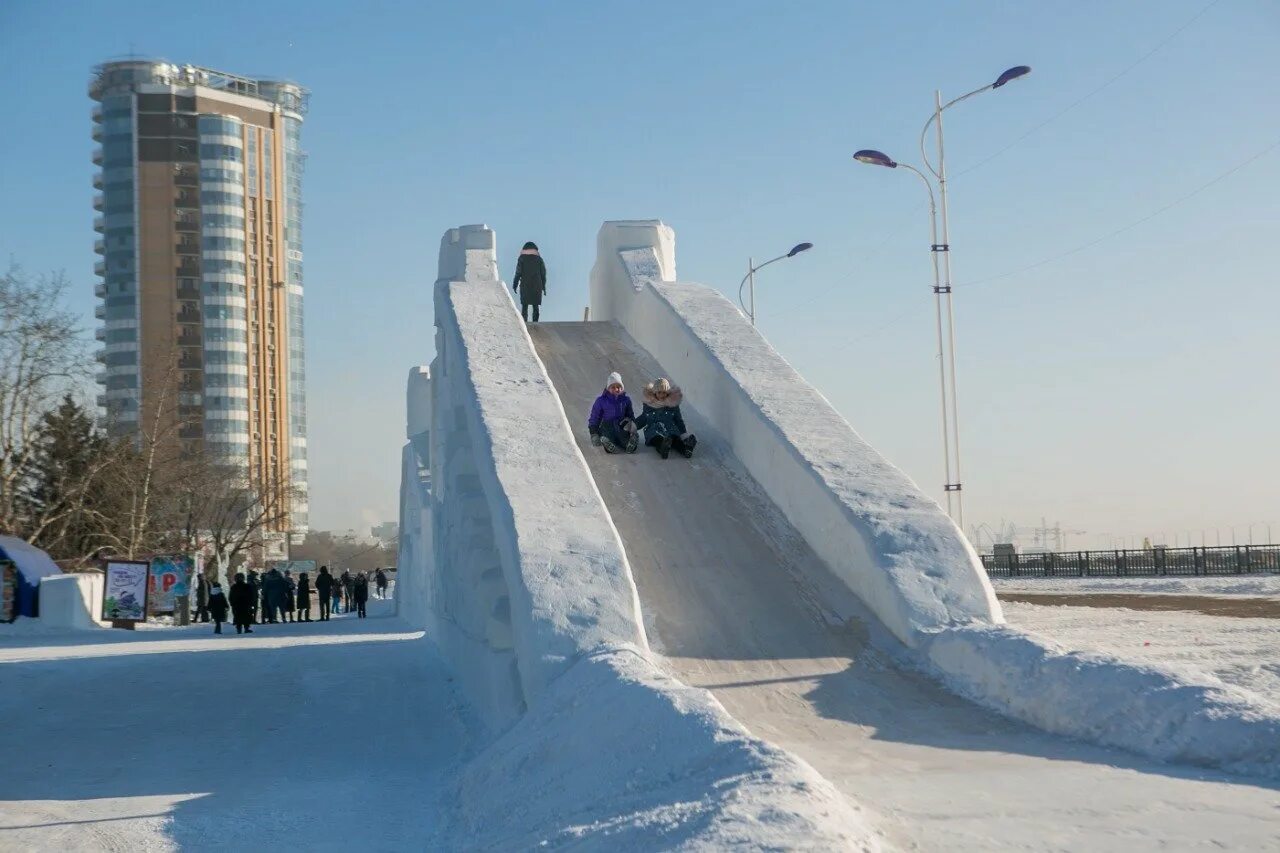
{"left": 0, "top": 601, "right": 467, "bottom": 850}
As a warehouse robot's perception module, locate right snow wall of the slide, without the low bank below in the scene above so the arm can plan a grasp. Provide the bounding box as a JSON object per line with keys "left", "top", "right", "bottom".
{"left": 591, "top": 220, "right": 1002, "bottom": 647}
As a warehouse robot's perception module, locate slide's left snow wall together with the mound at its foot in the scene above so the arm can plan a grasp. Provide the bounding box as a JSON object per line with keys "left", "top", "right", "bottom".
{"left": 399, "top": 225, "right": 873, "bottom": 849}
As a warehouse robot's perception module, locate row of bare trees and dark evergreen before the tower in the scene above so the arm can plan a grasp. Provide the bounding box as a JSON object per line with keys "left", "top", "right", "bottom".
{"left": 0, "top": 265, "right": 293, "bottom": 574}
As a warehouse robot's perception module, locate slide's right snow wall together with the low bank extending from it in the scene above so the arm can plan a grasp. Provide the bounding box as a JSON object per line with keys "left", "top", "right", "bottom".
{"left": 591, "top": 220, "right": 1280, "bottom": 776}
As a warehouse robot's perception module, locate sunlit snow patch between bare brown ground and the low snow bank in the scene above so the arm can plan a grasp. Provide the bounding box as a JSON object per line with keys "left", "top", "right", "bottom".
{"left": 1005, "top": 602, "right": 1280, "bottom": 716}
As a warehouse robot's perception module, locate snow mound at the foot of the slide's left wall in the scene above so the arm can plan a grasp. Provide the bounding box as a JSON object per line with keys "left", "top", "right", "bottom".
{"left": 447, "top": 648, "right": 878, "bottom": 850}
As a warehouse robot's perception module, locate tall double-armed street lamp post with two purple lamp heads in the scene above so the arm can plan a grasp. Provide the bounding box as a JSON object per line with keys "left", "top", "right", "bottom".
{"left": 854, "top": 65, "right": 1032, "bottom": 530}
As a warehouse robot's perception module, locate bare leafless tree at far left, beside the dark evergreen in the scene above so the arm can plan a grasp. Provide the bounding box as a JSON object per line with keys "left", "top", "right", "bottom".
{"left": 0, "top": 264, "right": 88, "bottom": 532}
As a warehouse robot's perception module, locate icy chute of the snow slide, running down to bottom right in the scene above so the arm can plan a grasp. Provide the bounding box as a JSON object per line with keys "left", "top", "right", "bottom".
{"left": 531, "top": 323, "right": 1280, "bottom": 852}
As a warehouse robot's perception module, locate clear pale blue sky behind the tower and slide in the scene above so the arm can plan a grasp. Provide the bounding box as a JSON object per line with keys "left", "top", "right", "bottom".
{"left": 0, "top": 0, "right": 1280, "bottom": 547}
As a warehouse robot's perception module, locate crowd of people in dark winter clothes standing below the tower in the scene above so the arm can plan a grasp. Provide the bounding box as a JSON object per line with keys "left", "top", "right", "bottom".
{"left": 196, "top": 566, "right": 388, "bottom": 634}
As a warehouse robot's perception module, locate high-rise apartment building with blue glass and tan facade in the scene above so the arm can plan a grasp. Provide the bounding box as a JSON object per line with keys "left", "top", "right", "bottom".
{"left": 90, "top": 60, "right": 307, "bottom": 532}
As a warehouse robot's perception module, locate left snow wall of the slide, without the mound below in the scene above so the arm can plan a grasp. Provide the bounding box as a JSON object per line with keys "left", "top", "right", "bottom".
{"left": 419, "top": 225, "right": 648, "bottom": 724}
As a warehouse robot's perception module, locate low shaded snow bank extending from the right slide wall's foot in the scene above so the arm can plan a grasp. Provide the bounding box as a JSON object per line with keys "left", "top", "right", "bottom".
{"left": 928, "top": 625, "right": 1280, "bottom": 779}
